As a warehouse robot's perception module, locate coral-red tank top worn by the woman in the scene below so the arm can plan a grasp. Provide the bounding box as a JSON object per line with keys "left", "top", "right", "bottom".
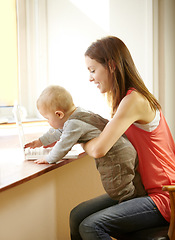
{"left": 125, "top": 91, "right": 175, "bottom": 221}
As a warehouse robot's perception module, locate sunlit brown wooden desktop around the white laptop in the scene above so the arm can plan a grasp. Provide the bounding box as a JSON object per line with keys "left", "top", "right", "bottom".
{"left": 0, "top": 122, "right": 85, "bottom": 192}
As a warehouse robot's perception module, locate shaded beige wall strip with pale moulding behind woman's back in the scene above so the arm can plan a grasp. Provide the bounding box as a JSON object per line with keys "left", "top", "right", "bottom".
{"left": 153, "top": 0, "right": 175, "bottom": 138}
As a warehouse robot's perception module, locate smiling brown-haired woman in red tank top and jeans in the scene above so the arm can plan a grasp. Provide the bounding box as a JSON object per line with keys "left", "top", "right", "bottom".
{"left": 70, "top": 37, "right": 175, "bottom": 240}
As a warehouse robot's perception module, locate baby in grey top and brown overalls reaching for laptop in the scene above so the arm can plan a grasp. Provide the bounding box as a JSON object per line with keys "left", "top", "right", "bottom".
{"left": 25, "top": 86, "right": 146, "bottom": 202}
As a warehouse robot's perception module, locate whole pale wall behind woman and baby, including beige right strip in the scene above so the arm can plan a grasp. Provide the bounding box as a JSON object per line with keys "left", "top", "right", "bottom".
{"left": 17, "top": 0, "right": 175, "bottom": 137}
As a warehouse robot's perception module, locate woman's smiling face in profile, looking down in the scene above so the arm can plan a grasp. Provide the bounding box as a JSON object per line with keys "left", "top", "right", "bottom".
{"left": 85, "top": 56, "right": 111, "bottom": 93}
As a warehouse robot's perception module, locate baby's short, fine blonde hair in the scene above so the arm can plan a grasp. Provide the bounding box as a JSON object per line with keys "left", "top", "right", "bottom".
{"left": 37, "top": 85, "right": 74, "bottom": 113}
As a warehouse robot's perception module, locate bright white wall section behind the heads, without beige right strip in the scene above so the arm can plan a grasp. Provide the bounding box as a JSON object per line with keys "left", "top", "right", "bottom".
{"left": 18, "top": 0, "right": 153, "bottom": 120}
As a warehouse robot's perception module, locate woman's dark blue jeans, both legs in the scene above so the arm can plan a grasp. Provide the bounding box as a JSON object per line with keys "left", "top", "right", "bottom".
{"left": 70, "top": 194, "right": 168, "bottom": 240}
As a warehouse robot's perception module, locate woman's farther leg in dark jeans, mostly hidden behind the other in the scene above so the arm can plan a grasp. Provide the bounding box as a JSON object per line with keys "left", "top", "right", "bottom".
{"left": 70, "top": 194, "right": 118, "bottom": 240}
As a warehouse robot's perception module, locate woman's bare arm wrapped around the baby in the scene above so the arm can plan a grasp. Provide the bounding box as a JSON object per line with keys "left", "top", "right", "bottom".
{"left": 83, "top": 91, "right": 154, "bottom": 158}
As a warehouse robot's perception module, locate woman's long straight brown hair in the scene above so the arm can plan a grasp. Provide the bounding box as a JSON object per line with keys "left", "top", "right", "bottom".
{"left": 85, "top": 36, "right": 161, "bottom": 116}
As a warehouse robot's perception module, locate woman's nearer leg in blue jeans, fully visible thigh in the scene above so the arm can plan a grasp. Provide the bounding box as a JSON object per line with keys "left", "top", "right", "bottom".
{"left": 78, "top": 196, "right": 168, "bottom": 240}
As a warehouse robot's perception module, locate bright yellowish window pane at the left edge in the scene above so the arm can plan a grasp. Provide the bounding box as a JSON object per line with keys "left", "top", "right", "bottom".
{"left": 0, "top": 1, "right": 18, "bottom": 123}
